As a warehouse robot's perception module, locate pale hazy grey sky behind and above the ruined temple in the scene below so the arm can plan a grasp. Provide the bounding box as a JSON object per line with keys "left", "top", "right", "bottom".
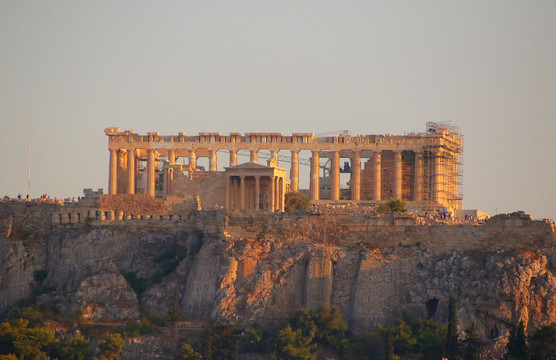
{"left": 0, "top": 0, "right": 556, "bottom": 218}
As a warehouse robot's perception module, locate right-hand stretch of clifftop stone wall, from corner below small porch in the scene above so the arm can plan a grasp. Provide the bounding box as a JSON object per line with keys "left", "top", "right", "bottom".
{"left": 225, "top": 212, "right": 556, "bottom": 252}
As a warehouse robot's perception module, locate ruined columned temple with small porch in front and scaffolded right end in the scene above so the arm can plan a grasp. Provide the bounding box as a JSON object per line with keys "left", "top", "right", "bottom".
{"left": 105, "top": 122, "right": 463, "bottom": 211}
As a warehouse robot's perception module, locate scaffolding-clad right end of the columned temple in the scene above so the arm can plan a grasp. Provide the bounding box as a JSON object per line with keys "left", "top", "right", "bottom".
{"left": 423, "top": 121, "right": 463, "bottom": 210}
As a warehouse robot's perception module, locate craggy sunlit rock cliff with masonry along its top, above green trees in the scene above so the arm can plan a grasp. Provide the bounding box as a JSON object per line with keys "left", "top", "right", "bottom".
{"left": 0, "top": 202, "right": 556, "bottom": 358}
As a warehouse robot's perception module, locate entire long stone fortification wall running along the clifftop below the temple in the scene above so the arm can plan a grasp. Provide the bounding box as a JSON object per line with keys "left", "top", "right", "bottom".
{"left": 5, "top": 199, "right": 556, "bottom": 252}
